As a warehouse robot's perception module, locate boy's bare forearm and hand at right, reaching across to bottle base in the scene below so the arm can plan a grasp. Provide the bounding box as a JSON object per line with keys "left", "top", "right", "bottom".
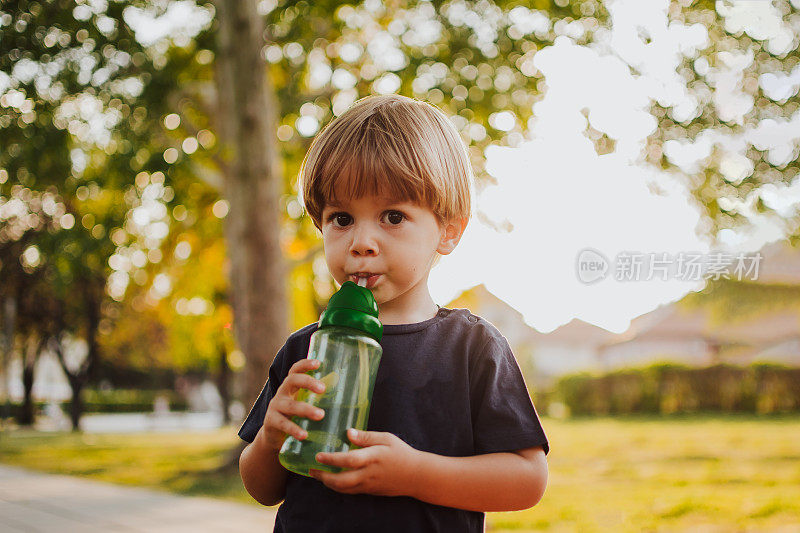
{"left": 312, "top": 430, "right": 547, "bottom": 512}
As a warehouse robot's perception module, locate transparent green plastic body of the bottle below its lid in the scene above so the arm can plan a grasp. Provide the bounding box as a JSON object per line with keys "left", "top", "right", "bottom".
{"left": 278, "top": 326, "right": 383, "bottom": 476}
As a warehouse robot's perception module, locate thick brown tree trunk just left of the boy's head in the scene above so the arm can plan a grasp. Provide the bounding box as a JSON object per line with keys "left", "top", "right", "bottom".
{"left": 214, "top": 0, "right": 289, "bottom": 406}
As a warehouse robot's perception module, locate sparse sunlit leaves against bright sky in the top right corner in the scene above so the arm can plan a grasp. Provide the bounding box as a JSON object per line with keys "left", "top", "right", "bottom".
{"left": 647, "top": 0, "right": 800, "bottom": 238}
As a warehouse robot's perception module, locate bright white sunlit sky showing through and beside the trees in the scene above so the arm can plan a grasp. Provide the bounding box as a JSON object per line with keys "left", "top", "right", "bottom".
{"left": 112, "top": 0, "right": 800, "bottom": 332}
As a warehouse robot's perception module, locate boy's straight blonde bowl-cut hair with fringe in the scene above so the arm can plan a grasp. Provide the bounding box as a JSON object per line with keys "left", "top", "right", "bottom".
{"left": 300, "top": 94, "right": 473, "bottom": 231}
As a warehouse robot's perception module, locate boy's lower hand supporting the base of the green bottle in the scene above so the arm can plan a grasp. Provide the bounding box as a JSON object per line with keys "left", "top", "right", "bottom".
{"left": 310, "top": 428, "right": 420, "bottom": 496}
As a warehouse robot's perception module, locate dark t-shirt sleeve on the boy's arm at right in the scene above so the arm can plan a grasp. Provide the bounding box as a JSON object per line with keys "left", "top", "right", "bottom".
{"left": 470, "top": 337, "right": 550, "bottom": 455}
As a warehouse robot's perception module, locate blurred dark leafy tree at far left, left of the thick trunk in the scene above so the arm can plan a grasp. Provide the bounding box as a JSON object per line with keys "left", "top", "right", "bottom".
{"left": 0, "top": 0, "right": 200, "bottom": 429}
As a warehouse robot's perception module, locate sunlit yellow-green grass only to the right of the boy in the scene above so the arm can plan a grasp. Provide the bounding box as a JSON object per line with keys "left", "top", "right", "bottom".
{"left": 487, "top": 416, "right": 800, "bottom": 532}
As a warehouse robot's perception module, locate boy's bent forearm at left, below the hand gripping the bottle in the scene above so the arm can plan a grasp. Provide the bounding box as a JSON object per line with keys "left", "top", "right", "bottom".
{"left": 239, "top": 427, "right": 287, "bottom": 505}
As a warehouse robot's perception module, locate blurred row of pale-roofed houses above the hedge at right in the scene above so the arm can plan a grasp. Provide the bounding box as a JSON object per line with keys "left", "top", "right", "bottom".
{"left": 447, "top": 241, "right": 800, "bottom": 388}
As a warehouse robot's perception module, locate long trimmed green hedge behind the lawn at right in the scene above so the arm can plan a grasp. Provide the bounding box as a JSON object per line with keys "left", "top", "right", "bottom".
{"left": 552, "top": 363, "right": 800, "bottom": 416}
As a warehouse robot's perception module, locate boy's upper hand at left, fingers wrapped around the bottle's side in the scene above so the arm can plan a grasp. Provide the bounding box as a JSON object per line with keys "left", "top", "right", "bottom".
{"left": 264, "top": 359, "right": 325, "bottom": 453}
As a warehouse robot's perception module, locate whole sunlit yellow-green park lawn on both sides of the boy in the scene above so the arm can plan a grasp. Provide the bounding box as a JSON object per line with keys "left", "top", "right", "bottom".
{"left": 0, "top": 416, "right": 800, "bottom": 532}
